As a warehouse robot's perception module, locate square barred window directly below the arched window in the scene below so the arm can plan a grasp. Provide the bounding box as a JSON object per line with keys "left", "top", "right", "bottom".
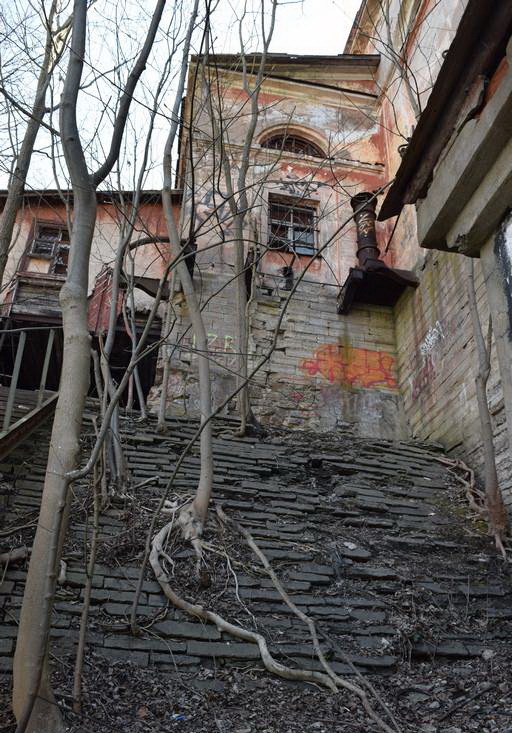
{"left": 268, "top": 197, "right": 317, "bottom": 256}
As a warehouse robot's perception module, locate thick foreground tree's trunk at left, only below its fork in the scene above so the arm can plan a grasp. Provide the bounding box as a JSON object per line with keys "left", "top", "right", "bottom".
{"left": 13, "top": 189, "right": 96, "bottom": 733}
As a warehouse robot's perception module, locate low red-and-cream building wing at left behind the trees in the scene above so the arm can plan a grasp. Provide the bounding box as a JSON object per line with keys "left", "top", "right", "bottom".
{"left": 0, "top": 190, "right": 181, "bottom": 406}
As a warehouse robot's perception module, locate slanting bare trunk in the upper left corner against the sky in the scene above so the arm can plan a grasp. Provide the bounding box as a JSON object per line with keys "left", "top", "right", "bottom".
{"left": 0, "top": 0, "right": 69, "bottom": 285}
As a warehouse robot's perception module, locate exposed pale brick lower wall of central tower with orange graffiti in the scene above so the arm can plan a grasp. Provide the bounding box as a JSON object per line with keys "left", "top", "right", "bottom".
{"left": 150, "top": 279, "right": 406, "bottom": 439}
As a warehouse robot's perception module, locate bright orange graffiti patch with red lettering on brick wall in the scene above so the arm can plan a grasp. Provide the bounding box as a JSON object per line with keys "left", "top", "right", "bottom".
{"left": 300, "top": 344, "right": 398, "bottom": 389}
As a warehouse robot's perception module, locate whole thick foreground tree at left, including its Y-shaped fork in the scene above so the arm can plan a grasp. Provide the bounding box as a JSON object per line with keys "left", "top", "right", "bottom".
{"left": 13, "top": 0, "right": 165, "bottom": 733}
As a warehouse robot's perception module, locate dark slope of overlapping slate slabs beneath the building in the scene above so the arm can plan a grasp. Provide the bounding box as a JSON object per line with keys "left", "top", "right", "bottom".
{"left": 0, "top": 408, "right": 512, "bottom": 678}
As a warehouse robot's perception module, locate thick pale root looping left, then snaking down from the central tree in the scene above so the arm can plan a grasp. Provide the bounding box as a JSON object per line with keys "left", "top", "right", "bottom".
{"left": 149, "top": 510, "right": 398, "bottom": 733}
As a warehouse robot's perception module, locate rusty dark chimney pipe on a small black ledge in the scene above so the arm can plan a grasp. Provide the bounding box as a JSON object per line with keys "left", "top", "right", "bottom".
{"left": 338, "top": 191, "right": 419, "bottom": 315}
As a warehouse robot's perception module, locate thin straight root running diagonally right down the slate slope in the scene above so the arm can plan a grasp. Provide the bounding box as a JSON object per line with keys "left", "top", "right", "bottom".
{"left": 217, "top": 506, "right": 400, "bottom": 733}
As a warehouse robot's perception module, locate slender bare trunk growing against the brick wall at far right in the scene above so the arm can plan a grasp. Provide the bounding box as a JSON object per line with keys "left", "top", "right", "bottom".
{"left": 467, "top": 259, "right": 507, "bottom": 553}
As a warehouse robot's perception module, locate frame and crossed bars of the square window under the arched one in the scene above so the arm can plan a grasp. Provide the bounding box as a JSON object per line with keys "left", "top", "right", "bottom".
{"left": 267, "top": 193, "right": 319, "bottom": 257}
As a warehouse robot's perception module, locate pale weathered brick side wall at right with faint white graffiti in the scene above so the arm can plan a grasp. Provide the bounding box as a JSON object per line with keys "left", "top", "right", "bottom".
{"left": 395, "top": 251, "right": 512, "bottom": 505}
